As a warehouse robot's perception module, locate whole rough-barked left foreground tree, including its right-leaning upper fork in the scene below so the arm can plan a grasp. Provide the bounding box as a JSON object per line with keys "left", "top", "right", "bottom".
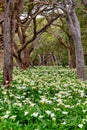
{"left": 3, "top": 0, "right": 23, "bottom": 86}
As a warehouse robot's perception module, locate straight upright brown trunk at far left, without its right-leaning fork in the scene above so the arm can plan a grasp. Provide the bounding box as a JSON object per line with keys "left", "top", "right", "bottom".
{"left": 3, "top": 0, "right": 13, "bottom": 86}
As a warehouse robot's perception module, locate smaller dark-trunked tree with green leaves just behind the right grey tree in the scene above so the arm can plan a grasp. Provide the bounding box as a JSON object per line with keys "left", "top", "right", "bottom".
{"left": 47, "top": 18, "right": 76, "bottom": 69}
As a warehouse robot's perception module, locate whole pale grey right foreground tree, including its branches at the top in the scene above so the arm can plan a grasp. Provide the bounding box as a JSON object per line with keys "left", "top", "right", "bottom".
{"left": 33, "top": 0, "right": 86, "bottom": 80}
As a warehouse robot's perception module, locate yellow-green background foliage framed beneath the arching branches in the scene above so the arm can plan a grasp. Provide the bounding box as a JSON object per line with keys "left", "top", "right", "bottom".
{"left": 31, "top": 31, "right": 68, "bottom": 66}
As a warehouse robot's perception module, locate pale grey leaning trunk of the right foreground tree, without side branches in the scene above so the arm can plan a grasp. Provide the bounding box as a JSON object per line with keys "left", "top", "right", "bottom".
{"left": 67, "top": 0, "right": 86, "bottom": 80}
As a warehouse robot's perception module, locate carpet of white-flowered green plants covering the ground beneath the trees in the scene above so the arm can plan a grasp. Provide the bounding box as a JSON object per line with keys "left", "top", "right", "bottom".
{"left": 0, "top": 67, "right": 87, "bottom": 130}
